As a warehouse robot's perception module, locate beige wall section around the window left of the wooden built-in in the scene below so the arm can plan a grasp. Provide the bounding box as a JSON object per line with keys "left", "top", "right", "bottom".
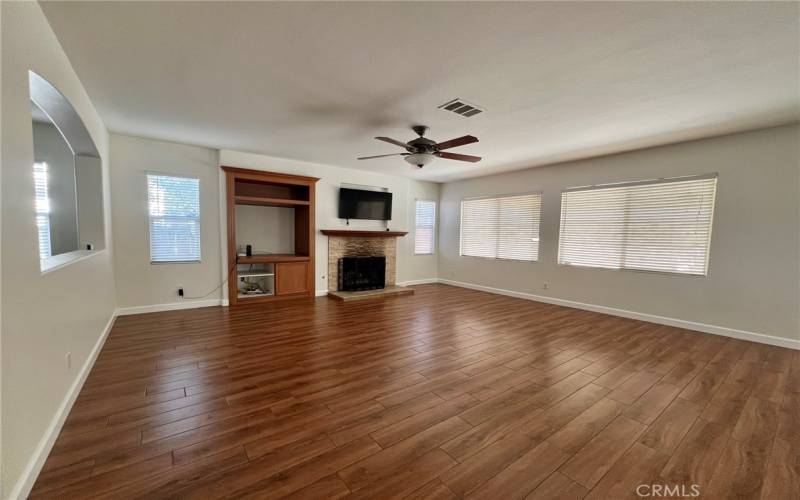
{"left": 111, "top": 134, "right": 221, "bottom": 308}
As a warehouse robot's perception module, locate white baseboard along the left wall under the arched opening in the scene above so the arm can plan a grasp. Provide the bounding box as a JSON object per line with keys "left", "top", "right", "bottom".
{"left": 6, "top": 311, "right": 117, "bottom": 500}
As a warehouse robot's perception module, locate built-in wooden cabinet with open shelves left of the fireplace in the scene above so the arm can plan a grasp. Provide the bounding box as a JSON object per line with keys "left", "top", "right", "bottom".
{"left": 222, "top": 166, "right": 319, "bottom": 305}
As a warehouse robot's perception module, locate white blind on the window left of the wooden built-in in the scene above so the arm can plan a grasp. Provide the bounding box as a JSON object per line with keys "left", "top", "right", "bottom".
{"left": 147, "top": 174, "right": 200, "bottom": 262}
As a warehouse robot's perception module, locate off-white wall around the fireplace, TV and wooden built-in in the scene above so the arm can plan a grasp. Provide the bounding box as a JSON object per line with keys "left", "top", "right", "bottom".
{"left": 220, "top": 150, "right": 439, "bottom": 291}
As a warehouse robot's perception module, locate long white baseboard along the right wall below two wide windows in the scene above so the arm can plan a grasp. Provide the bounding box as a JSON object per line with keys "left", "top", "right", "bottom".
{"left": 437, "top": 278, "right": 800, "bottom": 350}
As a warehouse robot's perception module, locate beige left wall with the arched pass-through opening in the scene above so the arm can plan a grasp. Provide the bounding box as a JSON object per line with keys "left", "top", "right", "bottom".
{"left": 0, "top": 2, "right": 115, "bottom": 498}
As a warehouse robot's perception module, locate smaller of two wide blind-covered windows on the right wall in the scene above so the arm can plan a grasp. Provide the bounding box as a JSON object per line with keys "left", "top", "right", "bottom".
{"left": 460, "top": 193, "right": 542, "bottom": 261}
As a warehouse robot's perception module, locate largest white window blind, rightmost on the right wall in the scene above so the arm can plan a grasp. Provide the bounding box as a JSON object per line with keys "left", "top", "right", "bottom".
{"left": 558, "top": 175, "right": 717, "bottom": 276}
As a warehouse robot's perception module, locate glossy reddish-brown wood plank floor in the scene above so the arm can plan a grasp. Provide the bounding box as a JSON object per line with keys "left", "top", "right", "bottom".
{"left": 32, "top": 285, "right": 800, "bottom": 500}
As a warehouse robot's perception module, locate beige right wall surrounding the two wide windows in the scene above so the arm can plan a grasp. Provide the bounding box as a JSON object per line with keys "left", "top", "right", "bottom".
{"left": 439, "top": 125, "right": 800, "bottom": 340}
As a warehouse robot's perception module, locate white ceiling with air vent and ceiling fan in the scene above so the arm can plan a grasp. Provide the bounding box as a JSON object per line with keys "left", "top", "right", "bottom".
{"left": 43, "top": 2, "right": 800, "bottom": 181}
